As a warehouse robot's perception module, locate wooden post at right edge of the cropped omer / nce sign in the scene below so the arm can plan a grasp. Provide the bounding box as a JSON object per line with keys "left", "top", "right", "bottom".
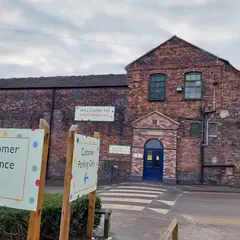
{"left": 27, "top": 119, "right": 50, "bottom": 240}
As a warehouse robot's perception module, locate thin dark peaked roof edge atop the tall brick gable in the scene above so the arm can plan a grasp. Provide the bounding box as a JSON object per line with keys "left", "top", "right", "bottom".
{"left": 125, "top": 35, "right": 239, "bottom": 72}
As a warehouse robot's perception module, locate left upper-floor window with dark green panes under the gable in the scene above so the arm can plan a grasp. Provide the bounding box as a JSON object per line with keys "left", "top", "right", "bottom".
{"left": 149, "top": 74, "right": 166, "bottom": 101}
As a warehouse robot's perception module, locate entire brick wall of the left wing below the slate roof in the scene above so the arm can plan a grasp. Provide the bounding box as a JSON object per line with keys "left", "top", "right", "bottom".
{"left": 0, "top": 88, "right": 131, "bottom": 179}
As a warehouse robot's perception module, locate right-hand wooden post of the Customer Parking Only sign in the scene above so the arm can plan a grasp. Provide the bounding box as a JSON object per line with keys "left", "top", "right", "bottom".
{"left": 87, "top": 132, "right": 100, "bottom": 238}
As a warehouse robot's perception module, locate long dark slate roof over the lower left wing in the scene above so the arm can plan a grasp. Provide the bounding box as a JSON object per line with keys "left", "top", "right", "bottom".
{"left": 0, "top": 74, "right": 127, "bottom": 89}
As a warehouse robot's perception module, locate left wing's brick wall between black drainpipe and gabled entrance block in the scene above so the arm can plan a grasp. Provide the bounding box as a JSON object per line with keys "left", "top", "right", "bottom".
{"left": 49, "top": 88, "right": 131, "bottom": 179}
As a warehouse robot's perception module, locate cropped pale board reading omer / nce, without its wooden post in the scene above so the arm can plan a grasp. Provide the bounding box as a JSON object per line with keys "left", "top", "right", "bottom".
{"left": 0, "top": 129, "right": 44, "bottom": 211}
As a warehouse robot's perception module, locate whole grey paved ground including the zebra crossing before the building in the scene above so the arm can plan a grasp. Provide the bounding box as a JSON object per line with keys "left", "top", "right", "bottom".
{"left": 46, "top": 182, "right": 240, "bottom": 240}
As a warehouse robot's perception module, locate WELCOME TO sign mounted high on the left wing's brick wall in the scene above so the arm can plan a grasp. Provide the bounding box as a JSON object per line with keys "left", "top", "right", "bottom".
{"left": 75, "top": 106, "right": 115, "bottom": 122}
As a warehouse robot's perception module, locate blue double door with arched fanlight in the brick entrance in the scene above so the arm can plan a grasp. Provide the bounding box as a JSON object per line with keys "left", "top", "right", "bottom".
{"left": 143, "top": 138, "right": 164, "bottom": 182}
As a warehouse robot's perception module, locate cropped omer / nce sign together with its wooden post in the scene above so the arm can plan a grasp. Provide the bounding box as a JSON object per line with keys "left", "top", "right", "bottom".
{"left": 0, "top": 119, "right": 50, "bottom": 240}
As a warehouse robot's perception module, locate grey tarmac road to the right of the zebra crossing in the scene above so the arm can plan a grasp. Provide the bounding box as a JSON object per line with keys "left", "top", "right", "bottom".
{"left": 168, "top": 192, "right": 240, "bottom": 240}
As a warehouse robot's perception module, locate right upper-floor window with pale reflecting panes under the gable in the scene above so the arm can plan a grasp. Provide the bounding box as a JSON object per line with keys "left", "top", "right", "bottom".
{"left": 184, "top": 72, "right": 202, "bottom": 100}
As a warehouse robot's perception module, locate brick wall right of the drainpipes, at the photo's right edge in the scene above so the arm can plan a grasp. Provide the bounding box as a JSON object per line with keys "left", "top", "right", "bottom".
{"left": 205, "top": 67, "right": 240, "bottom": 184}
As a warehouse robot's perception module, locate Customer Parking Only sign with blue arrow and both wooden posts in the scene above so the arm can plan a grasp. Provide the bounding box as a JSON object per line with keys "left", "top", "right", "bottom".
{"left": 59, "top": 125, "right": 100, "bottom": 240}
